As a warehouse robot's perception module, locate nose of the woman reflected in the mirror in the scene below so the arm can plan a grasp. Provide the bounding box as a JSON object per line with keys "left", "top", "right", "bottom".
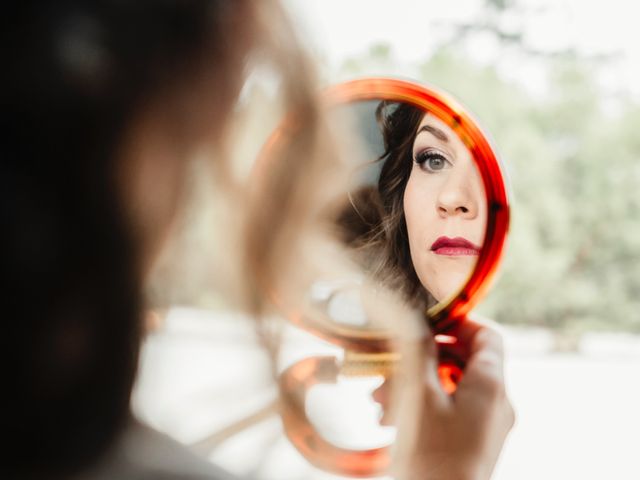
{"left": 436, "top": 165, "right": 478, "bottom": 219}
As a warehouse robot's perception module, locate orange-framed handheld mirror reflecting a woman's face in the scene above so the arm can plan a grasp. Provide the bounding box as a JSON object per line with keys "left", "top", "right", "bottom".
{"left": 252, "top": 78, "right": 509, "bottom": 477}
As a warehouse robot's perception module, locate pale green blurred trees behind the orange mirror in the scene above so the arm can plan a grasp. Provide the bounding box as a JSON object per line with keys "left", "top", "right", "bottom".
{"left": 340, "top": 0, "right": 640, "bottom": 343}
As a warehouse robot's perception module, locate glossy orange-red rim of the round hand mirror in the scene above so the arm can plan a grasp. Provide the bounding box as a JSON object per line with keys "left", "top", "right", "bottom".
{"left": 254, "top": 77, "right": 510, "bottom": 352}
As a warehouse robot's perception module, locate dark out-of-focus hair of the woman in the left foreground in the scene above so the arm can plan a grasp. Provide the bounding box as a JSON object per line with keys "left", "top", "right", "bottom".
{"left": 0, "top": 0, "right": 252, "bottom": 478}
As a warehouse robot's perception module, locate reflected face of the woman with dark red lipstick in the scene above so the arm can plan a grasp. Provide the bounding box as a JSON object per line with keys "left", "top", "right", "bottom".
{"left": 404, "top": 114, "right": 487, "bottom": 301}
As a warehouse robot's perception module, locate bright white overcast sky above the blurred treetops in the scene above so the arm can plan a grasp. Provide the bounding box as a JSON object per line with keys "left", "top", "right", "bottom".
{"left": 284, "top": 0, "right": 640, "bottom": 98}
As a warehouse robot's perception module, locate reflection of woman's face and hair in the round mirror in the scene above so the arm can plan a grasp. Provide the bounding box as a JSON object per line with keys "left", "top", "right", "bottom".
{"left": 336, "top": 101, "right": 487, "bottom": 314}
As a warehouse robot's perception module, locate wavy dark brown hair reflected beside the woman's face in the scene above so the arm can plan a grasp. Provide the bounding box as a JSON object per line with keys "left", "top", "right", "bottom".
{"left": 338, "top": 101, "right": 436, "bottom": 306}
